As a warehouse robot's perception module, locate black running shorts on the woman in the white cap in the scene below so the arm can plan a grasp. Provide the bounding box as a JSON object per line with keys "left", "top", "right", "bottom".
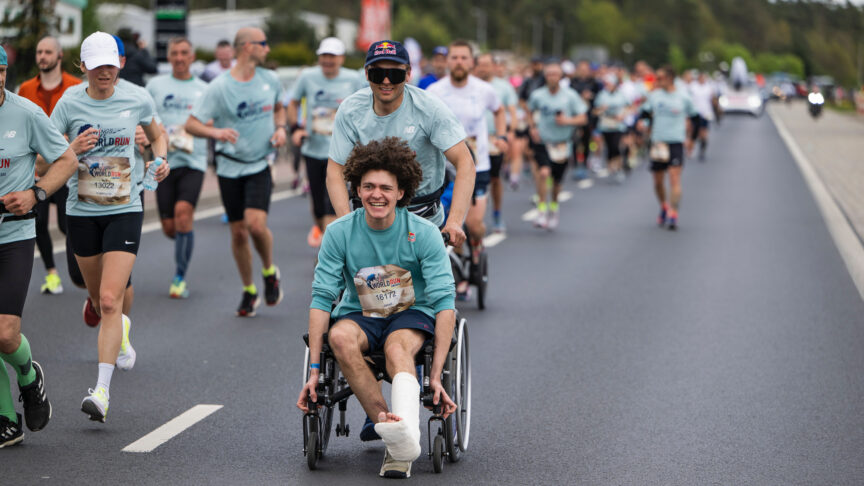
{"left": 66, "top": 212, "right": 144, "bottom": 257}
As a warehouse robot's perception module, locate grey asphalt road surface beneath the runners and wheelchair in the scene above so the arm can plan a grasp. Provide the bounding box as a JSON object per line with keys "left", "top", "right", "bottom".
{"left": 6, "top": 112, "right": 864, "bottom": 485}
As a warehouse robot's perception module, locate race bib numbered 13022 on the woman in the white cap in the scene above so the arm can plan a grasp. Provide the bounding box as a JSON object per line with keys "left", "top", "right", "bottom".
{"left": 78, "top": 156, "right": 132, "bottom": 206}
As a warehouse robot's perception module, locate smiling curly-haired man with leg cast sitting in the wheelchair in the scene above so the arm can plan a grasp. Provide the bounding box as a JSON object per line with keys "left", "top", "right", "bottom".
{"left": 297, "top": 137, "right": 456, "bottom": 477}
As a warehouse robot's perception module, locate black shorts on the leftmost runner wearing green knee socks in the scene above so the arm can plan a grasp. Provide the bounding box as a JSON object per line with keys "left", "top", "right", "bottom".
{"left": 0, "top": 238, "right": 36, "bottom": 316}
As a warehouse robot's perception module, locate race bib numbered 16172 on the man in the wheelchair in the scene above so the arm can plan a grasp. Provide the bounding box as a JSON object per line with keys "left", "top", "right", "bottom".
{"left": 354, "top": 265, "right": 414, "bottom": 317}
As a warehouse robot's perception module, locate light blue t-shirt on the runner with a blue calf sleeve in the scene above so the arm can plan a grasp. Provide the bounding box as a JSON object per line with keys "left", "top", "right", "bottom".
{"left": 147, "top": 74, "right": 207, "bottom": 172}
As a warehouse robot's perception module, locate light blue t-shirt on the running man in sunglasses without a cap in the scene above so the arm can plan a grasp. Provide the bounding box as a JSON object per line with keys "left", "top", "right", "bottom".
{"left": 192, "top": 67, "right": 282, "bottom": 179}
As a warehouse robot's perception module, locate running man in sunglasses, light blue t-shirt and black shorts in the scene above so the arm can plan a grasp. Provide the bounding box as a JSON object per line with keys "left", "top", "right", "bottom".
{"left": 186, "top": 27, "right": 288, "bottom": 317}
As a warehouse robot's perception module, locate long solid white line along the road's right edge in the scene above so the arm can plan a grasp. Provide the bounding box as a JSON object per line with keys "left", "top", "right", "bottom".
{"left": 768, "top": 109, "right": 864, "bottom": 300}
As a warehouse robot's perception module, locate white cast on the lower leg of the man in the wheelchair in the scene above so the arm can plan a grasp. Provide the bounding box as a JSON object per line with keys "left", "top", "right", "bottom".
{"left": 375, "top": 372, "right": 420, "bottom": 461}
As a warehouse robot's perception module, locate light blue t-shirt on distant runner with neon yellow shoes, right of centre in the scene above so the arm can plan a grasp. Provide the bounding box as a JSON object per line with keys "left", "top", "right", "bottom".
{"left": 528, "top": 86, "right": 588, "bottom": 152}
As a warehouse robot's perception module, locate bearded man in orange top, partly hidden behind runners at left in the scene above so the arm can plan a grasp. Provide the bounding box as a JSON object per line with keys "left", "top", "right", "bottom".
{"left": 18, "top": 37, "right": 81, "bottom": 294}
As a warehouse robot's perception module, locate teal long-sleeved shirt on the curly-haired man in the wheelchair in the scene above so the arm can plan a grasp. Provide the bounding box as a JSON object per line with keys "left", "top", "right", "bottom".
{"left": 310, "top": 208, "right": 456, "bottom": 320}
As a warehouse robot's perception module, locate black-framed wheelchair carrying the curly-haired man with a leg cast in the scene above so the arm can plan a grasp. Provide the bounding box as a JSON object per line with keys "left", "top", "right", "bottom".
{"left": 303, "top": 311, "right": 471, "bottom": 473}
